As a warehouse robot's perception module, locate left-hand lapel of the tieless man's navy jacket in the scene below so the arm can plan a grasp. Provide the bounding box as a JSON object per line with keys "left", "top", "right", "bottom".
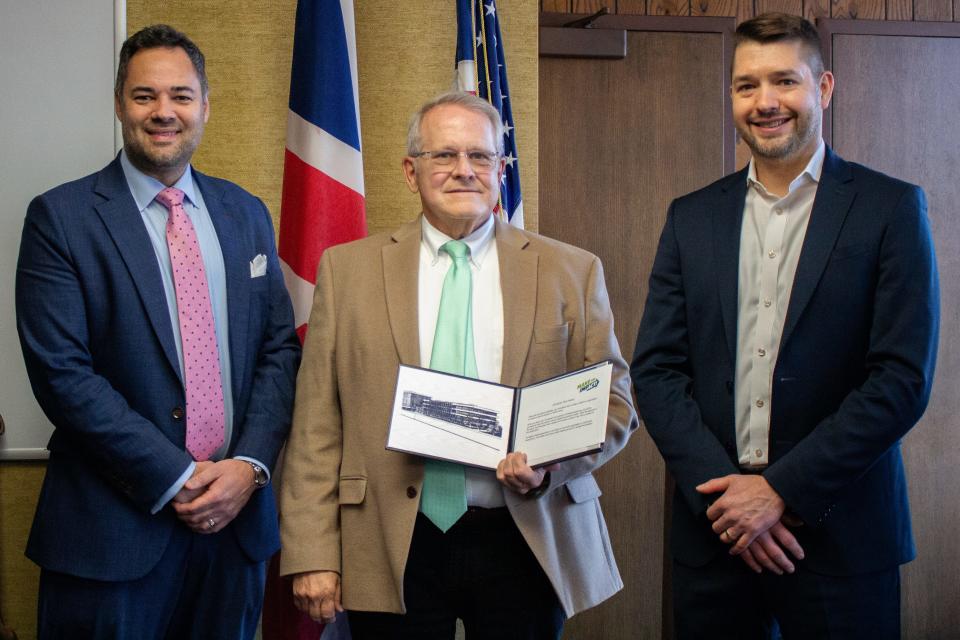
{"left": 712, "top": 168, "right": 748, "bottom": 361}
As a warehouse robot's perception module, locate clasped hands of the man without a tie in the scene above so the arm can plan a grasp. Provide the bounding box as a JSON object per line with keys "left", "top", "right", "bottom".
{"left": 697, "top": 474, "right": 803, "bottom": 575}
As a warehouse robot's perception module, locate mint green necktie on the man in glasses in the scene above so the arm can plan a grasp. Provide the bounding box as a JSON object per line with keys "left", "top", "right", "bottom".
{"left": 420, "top": 240, "right": 477, "bottom": 532}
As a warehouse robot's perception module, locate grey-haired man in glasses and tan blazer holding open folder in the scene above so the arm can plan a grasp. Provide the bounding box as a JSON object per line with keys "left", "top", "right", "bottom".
{"left": 281, "top": 94, "right": 638, "bottom": 640}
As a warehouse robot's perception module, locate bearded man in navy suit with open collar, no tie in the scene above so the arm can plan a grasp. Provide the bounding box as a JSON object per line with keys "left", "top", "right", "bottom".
{"left": 632, "top": 14, "right": 939, "bottom": 639}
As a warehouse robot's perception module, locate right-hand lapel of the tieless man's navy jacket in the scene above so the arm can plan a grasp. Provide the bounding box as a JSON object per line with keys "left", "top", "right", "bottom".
{"left": 780, "top": 147, "right": 856, "bottom": 349}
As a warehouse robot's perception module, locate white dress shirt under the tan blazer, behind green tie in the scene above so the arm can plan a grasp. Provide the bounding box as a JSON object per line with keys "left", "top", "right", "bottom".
{"left": 417, "top": 215, "right": 506, "bottom": 508}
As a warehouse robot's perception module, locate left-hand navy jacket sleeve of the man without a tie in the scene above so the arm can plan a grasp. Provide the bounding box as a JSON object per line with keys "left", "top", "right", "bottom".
{"left": 630, "top": 202, "right": 739, "bottom": 514}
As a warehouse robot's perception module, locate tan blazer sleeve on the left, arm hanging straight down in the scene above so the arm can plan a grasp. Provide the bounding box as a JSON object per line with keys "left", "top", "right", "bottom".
{"left": 280, "top": 251, "right": 343, "bottom": 575}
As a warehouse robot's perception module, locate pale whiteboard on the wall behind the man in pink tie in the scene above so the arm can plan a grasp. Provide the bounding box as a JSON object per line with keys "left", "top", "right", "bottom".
{"left": 0, "top": 0, "right": 126, "bottom": 460}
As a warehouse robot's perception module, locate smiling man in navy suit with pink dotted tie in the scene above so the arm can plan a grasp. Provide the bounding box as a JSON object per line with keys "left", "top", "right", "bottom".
{"left": 16, "top": 25, "right": 300, "bottom": 638}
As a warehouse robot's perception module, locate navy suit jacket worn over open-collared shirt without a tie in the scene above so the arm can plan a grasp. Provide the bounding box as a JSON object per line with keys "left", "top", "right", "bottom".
{"left": 631, "top": 148, "right": 939, "bottom": 575}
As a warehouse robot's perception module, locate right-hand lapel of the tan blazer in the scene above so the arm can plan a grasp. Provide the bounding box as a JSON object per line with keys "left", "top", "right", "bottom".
{"left": 494, "top": 218, "right": 539, "bottom": 387}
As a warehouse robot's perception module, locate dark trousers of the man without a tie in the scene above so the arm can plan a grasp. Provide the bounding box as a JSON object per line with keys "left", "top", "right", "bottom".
{"left": 673, "top": 553, "right": 900, "bottom": 640}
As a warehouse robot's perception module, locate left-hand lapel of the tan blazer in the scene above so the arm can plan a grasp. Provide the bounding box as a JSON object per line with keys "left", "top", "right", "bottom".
{"left": 380, "top": 217, "right": 421, "bottom": 366}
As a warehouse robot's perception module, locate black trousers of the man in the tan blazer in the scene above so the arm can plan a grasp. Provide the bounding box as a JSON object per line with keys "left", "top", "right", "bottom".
{"left": 349, "top": 508, "right": 564, "bottom": 640}
